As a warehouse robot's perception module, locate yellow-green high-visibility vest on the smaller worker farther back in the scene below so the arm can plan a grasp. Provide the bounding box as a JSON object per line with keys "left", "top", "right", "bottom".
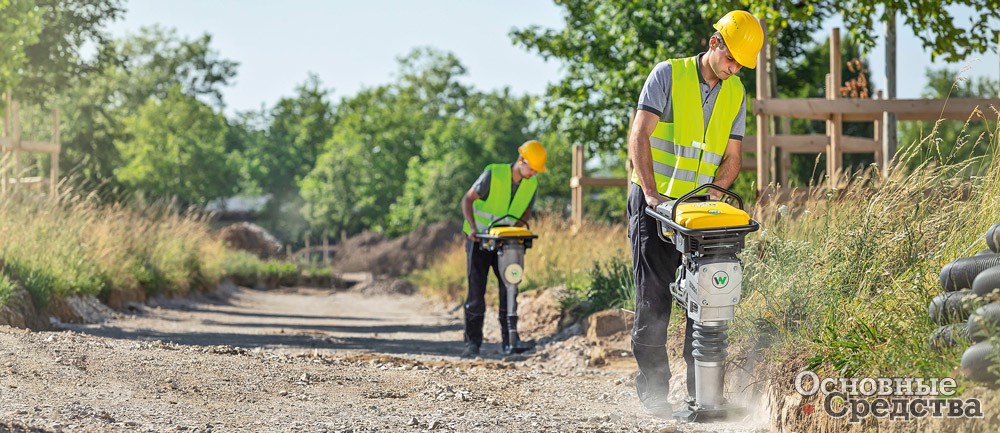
{"left": 463, "top": 164, "right": 538, "bottom": 234}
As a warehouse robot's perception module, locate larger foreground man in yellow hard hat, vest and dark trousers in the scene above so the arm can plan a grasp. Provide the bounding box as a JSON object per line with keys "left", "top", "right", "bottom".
{"left": 627, "top": 11, "right": 764, "bottom": 417}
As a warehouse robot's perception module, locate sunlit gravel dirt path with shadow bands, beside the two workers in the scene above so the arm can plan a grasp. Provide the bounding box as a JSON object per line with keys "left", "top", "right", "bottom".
{"left": 0, "top": 288, "right": 760, "bottom": 432}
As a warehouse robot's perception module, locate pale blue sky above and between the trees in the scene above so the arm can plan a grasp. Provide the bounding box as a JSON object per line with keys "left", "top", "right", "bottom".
{"left": 110, "top": 0, "right": 1000, "bottom": 114}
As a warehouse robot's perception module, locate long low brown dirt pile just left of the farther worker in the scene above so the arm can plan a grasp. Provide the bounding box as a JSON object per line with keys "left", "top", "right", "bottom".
{"left": 331, "top": 221, "right": 463, "bottom": 277}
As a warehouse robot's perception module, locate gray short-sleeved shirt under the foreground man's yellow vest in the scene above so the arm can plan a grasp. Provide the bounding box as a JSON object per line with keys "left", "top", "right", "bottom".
{"left": 638, "top": 53, "right": 747, "bottom": 141}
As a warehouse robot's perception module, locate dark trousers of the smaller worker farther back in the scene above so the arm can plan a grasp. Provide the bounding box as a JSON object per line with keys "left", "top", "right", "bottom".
{"left": 465, "top": 240, "right": 507, "bottom": 346}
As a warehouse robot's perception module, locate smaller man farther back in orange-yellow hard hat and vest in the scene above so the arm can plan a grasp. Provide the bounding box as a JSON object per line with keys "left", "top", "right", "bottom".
{"left": 462, "top": 140, "right": 545, "bottom": 357}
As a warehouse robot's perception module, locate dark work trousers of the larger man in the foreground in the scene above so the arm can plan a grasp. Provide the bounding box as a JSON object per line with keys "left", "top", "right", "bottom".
{"left": 627, "top": 183, "right": 694, "bottom": 401}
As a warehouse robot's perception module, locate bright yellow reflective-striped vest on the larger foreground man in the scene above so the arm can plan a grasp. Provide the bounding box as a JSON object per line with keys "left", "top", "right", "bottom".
{"left": 632, "top": 56, "right": 745, "bottom": 198}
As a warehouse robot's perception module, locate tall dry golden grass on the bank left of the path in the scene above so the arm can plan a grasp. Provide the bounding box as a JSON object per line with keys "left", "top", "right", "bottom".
{"left": 0, "top": 191, "right": 227, "bottom": 305}
